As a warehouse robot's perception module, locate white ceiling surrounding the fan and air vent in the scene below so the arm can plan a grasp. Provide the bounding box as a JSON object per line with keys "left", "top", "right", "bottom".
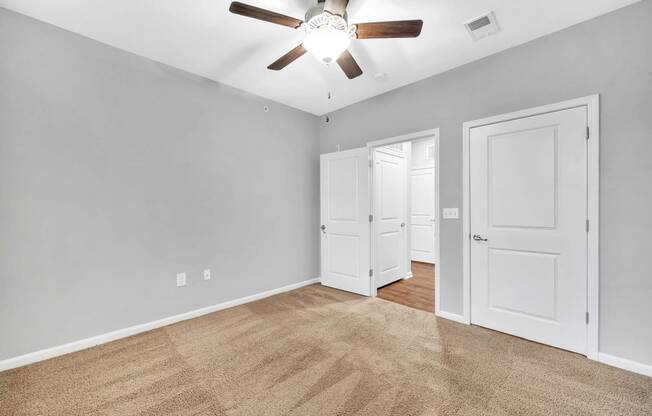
{"left": 0, "top": 0, "right": 638, "bottom": 115}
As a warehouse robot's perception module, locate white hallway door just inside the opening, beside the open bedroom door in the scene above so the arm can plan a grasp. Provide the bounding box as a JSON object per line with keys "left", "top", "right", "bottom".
{"left": 374, "top": 147, "right": 409, "bottom": 287}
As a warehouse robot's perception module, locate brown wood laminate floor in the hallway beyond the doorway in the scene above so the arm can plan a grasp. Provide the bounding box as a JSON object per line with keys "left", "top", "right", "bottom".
{"left": 378, "top": 261, "right": 435, "bottom": 312}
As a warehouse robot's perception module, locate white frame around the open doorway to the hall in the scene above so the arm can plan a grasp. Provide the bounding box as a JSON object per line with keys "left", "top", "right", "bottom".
{"left": 367, "top": 128, "right": 441, "bottom": 298}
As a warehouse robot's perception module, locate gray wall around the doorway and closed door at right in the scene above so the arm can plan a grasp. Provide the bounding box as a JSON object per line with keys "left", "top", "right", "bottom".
{"left": 320, "top": 0, "right": 652, "bottom": 364}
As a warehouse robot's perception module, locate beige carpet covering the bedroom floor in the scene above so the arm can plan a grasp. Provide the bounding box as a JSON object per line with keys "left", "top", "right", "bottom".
{"left": 0, "top": 285, "right": 652, "bottom": 416}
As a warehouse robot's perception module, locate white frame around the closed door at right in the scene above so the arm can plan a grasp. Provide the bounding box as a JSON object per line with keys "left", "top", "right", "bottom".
{"left": 460, "top": 94, "right": 600, "bottom": 360}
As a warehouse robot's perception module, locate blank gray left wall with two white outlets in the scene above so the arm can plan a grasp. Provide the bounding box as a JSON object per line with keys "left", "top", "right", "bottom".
{"left": 0, "top": 9, "right": 319, "bottom": 360}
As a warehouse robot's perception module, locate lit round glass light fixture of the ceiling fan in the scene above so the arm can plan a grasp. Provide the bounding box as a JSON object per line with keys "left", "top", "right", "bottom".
{"left": 303, "top": 12, "right": 355, "bottom": 64}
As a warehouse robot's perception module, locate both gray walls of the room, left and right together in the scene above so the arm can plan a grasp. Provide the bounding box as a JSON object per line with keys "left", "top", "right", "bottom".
{"left": 0, "top": 0, "right": 652, "bottom": 364}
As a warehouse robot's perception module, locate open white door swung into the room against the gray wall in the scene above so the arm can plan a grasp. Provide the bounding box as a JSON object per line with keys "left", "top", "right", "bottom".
{"left": 320, "top": 148, "right": 371, "bottom": 296}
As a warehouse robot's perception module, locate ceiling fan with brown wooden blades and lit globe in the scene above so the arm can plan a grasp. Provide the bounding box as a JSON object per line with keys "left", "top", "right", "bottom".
{"left": 229, "top": 0, "right": 423, "bottom": 79}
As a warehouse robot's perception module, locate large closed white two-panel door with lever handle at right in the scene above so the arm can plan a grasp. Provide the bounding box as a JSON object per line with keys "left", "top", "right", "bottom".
{"left": 470, "top": 107, "right": 587, "bottom": 353}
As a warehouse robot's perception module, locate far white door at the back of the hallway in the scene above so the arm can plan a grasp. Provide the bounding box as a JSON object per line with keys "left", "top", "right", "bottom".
{"left": 410, "top": 167, "right": 437, "bottom": 264}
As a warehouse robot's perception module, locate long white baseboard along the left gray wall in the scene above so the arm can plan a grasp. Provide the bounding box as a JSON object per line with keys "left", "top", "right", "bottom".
{"left": 0, "top": 278, "right": 320, "bottom": 371}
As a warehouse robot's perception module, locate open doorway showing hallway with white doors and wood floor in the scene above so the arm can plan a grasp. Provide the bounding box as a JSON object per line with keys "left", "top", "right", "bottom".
{"left": 367, "top": 130, "right": 439, "bottom": 313}
